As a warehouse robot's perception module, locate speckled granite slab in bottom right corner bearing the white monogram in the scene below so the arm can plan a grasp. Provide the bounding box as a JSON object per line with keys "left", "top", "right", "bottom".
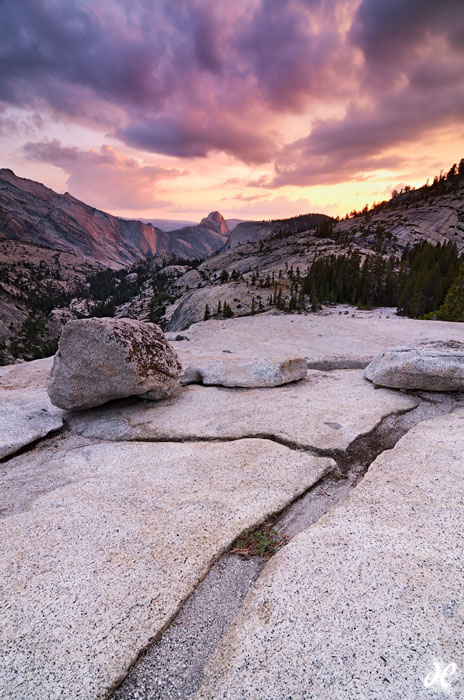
{"left": 195, "top": 410, "right": 464, "bottom": 700}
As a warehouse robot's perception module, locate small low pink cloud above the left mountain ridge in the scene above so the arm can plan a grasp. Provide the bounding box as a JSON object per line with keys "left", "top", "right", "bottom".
{"left": 24, "top": 139, "right": 182, "bottom": 209}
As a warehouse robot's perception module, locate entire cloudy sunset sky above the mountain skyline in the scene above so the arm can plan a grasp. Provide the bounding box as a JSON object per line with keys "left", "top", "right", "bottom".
{"left": 0, "top": 0, "right": 464, "bottom": 221}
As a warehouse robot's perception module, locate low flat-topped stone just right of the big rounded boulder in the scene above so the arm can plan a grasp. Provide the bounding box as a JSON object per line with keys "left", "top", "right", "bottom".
{"left": 181, "top": 356, "right": 308, "bottom": 388}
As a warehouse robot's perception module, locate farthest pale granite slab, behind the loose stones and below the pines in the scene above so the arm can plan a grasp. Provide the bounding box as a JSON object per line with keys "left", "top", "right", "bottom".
{"left": 170, "top": 305, "right": 463, "bottom": 370}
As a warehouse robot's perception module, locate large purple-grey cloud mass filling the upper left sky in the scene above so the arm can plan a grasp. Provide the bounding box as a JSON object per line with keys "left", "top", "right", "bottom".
{"left": 0, "top": 0, "right": 352, "bottom": 162}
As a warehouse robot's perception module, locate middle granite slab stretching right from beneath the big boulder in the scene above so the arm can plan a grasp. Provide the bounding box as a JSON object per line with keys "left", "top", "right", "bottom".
{"left": 67, "top": 370, "right": 418, "bottom": 450}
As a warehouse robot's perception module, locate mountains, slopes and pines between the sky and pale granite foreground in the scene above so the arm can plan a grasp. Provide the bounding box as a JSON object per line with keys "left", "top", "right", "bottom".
{"left": 0, "top": 161, "right": 464, "bottom": 363}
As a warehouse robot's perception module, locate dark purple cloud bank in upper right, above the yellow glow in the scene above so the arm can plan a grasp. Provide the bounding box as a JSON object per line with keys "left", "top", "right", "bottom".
{"left": 263, "top": 0, "right": 464, "bottom": 187}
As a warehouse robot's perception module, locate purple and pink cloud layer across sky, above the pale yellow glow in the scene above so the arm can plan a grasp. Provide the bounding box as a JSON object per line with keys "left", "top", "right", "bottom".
{"left": 0, "top": 0, "right": 464, "bottom": 189}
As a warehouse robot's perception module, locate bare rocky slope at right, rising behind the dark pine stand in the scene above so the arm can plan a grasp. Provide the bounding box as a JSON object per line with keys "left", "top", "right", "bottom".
{"left": 150, "top": 179, "right": 464, "bottom": 331}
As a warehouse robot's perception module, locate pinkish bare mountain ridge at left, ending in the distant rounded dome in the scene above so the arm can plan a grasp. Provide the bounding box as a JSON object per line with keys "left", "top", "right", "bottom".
{"left": 0, "top": 169, "right": 229, "bottom": 269}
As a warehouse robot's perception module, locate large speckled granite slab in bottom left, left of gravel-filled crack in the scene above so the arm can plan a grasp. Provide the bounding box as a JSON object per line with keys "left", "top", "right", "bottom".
{"left": 0, "top": 440, "right": 334, "bottom": 700}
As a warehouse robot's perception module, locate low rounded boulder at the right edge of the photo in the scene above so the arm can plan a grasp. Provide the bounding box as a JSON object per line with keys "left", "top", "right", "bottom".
{"left": 364, "top": 340, "right": 464, "bottom": 391}
